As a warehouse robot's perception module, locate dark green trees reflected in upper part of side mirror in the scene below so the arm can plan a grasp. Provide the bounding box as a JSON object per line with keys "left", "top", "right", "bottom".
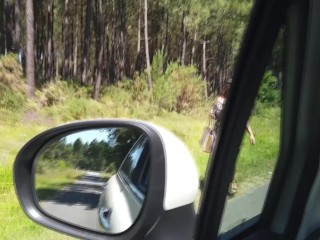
{"left": 37, "top": 128, "right": 141, "bottom": 174}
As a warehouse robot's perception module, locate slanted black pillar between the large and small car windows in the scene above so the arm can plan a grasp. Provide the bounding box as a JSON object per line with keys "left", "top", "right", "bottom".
{"left": 195, "top": 0, "right": 302, "bottom": 239}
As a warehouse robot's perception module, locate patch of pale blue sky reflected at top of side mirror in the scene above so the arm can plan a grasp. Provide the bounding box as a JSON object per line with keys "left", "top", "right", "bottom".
{"left": 65, "top": 129, "right": 109, "bottom": 143}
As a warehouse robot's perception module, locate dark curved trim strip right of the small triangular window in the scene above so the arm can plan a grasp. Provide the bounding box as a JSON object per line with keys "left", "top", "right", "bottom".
{"left": 260, "top": 1, "right": 309, "bottom": 231}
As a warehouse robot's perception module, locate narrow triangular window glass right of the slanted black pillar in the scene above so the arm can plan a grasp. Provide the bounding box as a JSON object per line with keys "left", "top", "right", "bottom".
{"left": 220, "top": 28, "right": 283, "bottom": 233}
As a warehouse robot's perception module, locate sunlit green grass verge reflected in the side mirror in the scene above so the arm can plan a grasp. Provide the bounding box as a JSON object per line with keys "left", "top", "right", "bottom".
{"left": 35, "top": 168, "right": 85, "bottom": 201}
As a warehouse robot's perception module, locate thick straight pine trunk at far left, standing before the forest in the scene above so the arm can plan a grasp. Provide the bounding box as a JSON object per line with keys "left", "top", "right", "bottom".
{"left": 26, "top": 0, "right": 35, "bottom": 98}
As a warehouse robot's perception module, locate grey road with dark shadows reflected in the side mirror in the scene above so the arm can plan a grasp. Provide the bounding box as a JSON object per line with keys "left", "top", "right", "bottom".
{"left": 39, "top": 172, "right": 107, "bottom": 230}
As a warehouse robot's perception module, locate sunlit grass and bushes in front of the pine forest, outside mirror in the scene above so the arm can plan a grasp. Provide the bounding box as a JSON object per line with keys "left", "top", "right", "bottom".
{"left": 0, "top": 54, "right": 280, "bottom": 239}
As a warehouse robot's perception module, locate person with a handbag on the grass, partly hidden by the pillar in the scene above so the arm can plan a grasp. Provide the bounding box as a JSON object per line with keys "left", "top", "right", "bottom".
{"left": 209, "top": 83, "right": 256, "bottom": 195}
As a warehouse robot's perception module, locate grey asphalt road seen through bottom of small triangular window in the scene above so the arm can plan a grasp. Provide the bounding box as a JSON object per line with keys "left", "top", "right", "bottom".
{"left": 220, "top": 182, "right": 269, "bottom": 233}
